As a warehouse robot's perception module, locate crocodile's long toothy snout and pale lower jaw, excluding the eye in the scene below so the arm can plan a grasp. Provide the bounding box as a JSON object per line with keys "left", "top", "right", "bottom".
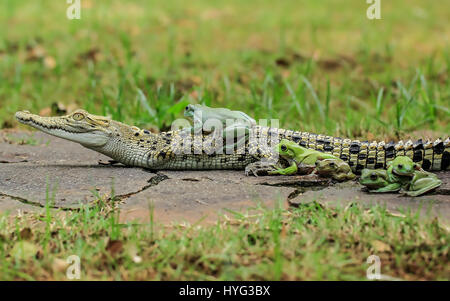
{"left": 15, "top": 111, "right": 109, "bottom": 147}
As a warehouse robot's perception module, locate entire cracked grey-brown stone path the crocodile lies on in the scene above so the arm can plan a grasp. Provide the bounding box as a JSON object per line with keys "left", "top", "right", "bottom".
{"left": 0, "top": 130, "right": 450, "bottom": 224}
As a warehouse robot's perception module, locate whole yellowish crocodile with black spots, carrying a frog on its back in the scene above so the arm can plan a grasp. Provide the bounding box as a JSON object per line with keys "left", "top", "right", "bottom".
{"left": 15, "top": 110, "right": 450, "bottom": 173}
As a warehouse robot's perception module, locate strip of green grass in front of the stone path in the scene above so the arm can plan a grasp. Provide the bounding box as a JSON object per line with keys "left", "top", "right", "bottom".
{"left": 0, "top": 198, "right": 450, "bottom": 280}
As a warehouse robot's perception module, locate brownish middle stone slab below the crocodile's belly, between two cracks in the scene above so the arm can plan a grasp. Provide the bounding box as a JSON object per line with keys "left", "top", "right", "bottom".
{"left": 121, "top": 171, "right": 295, "bottom": 223}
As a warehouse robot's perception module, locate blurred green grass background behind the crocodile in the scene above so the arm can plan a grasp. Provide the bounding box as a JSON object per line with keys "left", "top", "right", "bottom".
{"left": 0, "top": 0, "right": 450, "bottom": 140}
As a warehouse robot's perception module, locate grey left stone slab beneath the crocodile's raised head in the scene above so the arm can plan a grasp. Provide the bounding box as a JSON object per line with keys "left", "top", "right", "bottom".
{"left": 0, "top": 132, "right": 155, "bottom": 210}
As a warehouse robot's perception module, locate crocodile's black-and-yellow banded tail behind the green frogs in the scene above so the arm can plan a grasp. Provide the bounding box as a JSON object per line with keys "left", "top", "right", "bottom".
{"left": 280, "top": 130, "right": 450, "bottom": 172}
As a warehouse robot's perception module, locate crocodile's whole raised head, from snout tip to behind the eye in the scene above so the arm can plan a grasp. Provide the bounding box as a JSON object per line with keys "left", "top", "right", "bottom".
{"left": 16, "top": 110, "right": 113, "bottom": 147}
